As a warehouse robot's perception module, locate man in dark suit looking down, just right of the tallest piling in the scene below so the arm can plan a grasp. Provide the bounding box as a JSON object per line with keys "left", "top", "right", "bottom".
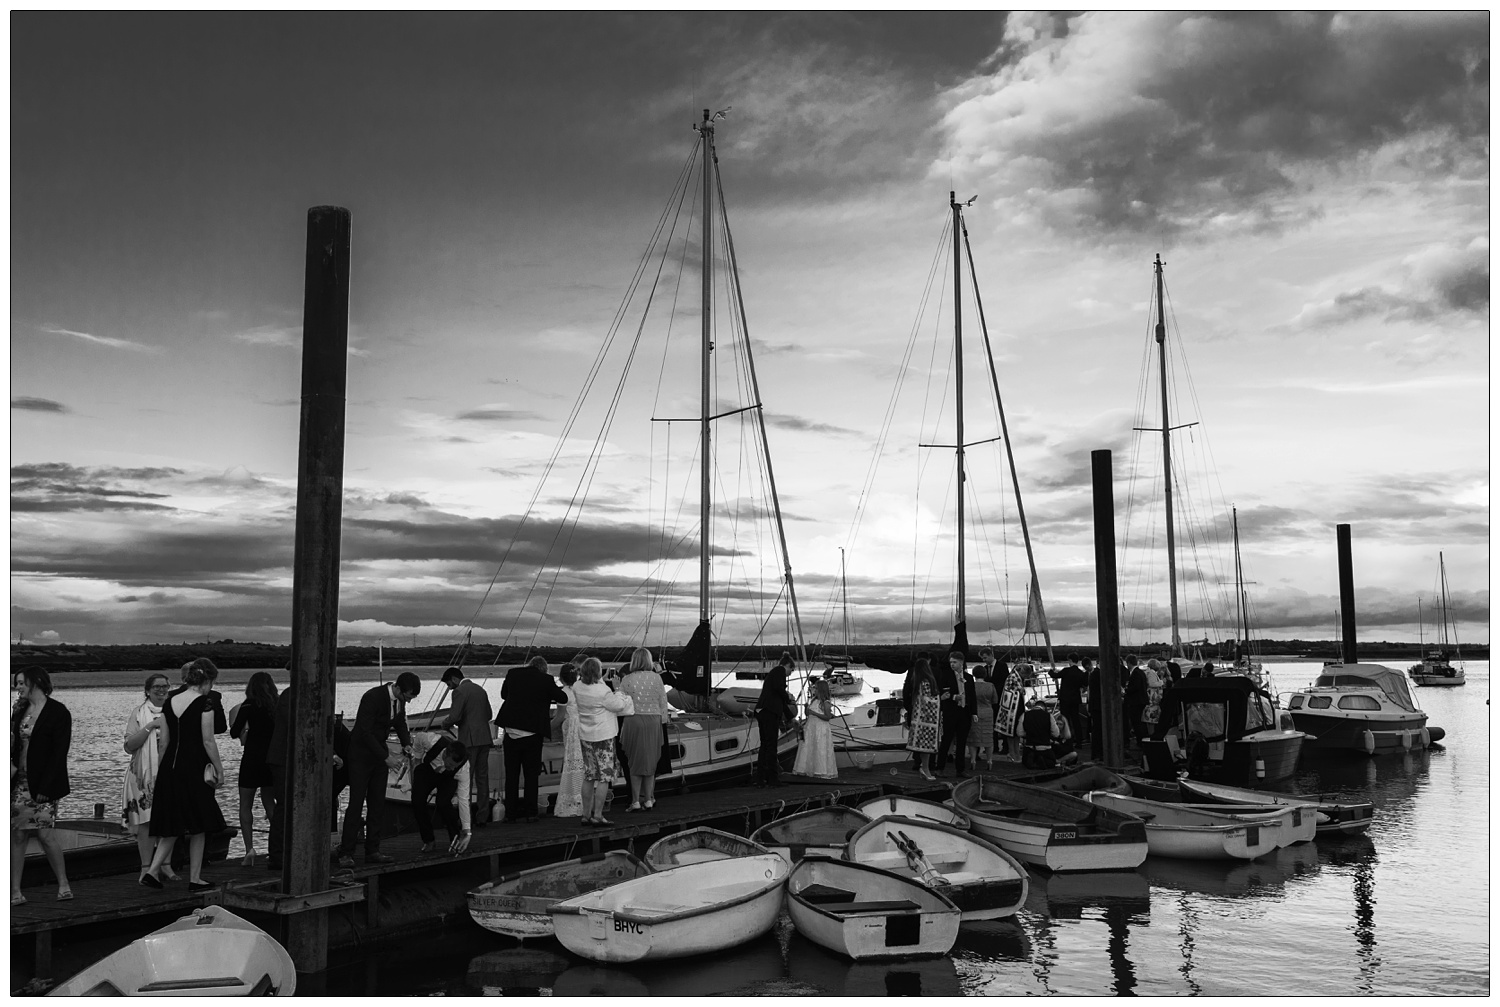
{"left": 338, "top": 671, "right": 422, "bottom": 867}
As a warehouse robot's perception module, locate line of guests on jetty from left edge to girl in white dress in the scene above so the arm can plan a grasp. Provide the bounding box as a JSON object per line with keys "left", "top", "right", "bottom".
{"left": 11, "top": 647, "right": 858, "bottom": 905}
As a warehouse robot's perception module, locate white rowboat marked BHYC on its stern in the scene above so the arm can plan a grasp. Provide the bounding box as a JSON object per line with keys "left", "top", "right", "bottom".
{"left": 552, "top": 852, "right": 791, "bottom": 962}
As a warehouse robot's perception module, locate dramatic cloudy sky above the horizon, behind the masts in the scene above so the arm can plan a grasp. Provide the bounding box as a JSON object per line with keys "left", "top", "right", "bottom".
{"left": 11, "top": 12, "right": 1490, "bottom": 654}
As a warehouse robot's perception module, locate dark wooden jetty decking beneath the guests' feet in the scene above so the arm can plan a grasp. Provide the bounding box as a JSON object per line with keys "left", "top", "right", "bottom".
{"left": 11, "top": 761, "right": 1029, "bottom": 989}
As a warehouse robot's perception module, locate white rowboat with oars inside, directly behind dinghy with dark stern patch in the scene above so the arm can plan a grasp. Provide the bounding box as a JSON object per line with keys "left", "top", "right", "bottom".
{"left": 845, "top": 818, "right": 1026, "bottom": 920}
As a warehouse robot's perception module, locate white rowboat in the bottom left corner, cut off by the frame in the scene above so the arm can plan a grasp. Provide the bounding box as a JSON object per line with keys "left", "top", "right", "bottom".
{"left": 48, "top": 905, "right": 297, "bottom": 996}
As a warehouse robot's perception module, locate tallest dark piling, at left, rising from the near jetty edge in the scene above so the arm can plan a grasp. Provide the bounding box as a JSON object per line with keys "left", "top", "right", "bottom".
{"left": 282, "top": 206, "right": 351, "bottom": 972}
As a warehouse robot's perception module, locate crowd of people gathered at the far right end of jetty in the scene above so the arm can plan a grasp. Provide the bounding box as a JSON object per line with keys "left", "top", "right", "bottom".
{"left": 902, "top": 647, "right": 1214, "bottom": 780}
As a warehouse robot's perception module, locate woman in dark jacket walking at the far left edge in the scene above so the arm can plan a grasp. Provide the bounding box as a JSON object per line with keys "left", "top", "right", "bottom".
{"left": 11, "top": 666, "right": 74, "bottom": 905}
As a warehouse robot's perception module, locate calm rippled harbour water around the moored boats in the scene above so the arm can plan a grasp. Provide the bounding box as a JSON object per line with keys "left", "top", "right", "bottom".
{"left": 46, "top": 660, "right": 1490, "bottom": 996}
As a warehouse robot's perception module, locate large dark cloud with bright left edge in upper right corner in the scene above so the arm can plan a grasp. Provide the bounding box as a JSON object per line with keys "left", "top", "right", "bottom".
{"left": 945, "top": 12, "right": 1490, "bottom": 236}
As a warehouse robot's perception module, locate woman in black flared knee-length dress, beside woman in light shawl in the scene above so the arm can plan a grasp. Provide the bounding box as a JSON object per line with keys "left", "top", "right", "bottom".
{"left": 141, "top": 657, "right": 224, "bottom": 891}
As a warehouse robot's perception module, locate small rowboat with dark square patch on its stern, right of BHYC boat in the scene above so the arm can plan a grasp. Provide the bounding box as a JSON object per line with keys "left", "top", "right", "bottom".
{"left": 786, "top": 854, "right": 960, "bottom": 960}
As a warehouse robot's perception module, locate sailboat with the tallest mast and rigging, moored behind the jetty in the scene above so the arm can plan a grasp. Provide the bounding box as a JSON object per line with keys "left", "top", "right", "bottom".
{"left": 387, "top": 110, "right": 806, "bottom": 803}
